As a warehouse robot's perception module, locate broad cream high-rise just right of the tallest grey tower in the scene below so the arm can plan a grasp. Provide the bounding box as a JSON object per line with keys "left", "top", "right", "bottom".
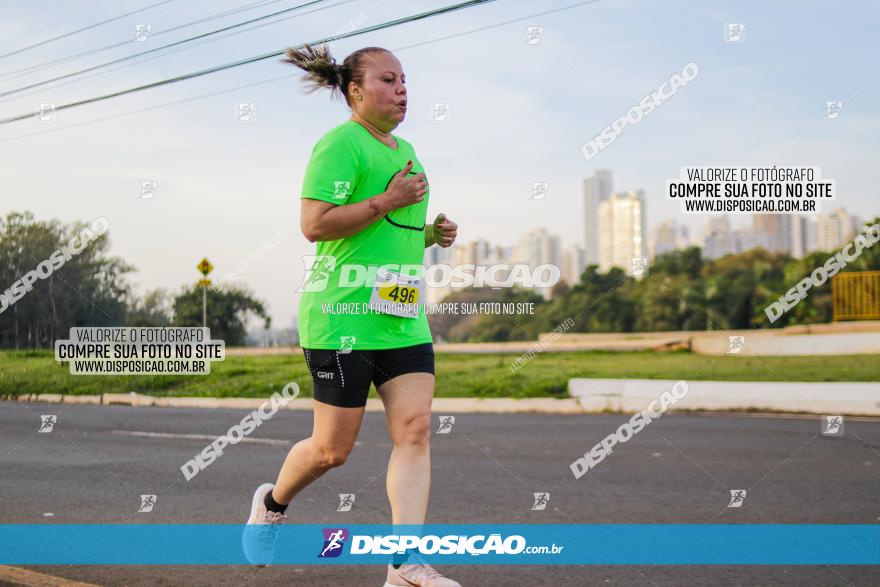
{"left": 598, "top": 190, "right": 647, "bottom": 272}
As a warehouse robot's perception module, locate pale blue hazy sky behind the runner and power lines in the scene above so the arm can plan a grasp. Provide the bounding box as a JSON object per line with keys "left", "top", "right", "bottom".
{"left": 0, "top": 0, "right": 880, "bottom": 328}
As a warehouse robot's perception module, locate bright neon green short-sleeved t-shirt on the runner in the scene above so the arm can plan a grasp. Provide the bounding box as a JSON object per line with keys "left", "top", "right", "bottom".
{"left": 298, "top": 119, "right": 432, "bottom": 350}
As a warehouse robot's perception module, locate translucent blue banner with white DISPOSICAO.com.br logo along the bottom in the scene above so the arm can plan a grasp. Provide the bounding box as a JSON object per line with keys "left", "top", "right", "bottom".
{"left": 0, "top": 524, "right": 880, "bottom": 565}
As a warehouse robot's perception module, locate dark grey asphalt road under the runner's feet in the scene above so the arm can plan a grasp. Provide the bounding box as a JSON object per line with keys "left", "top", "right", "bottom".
{"left": 0, "top": 402, "right": 880, "bottom": 587}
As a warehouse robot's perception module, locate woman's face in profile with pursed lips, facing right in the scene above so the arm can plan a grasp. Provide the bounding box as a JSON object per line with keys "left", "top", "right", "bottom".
{"left": 350, "top": 51, "right": 406, "bottom": 132}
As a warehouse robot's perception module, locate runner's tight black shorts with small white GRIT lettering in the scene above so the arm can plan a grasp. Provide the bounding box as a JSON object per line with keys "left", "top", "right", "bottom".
{"left": 303, "top": 342, "right": 434, "bottom": 408}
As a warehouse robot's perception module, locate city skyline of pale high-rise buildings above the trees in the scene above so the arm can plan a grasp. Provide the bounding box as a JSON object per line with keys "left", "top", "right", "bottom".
{"left": 426, "top": 169, "right": 880, "bottom": 282}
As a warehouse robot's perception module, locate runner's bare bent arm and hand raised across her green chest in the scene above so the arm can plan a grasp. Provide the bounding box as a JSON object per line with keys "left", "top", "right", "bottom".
{"left": 300, "top": 161, "right": 428, "bottom": 242}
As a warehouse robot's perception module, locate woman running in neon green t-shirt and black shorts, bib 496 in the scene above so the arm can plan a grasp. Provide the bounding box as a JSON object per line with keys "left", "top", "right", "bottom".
{"left": 245, "top": 46, "right": 460, "bottom": 587}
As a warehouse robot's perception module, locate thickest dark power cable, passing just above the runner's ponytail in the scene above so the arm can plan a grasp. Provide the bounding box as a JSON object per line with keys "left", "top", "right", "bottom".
{"left": 0, "top": 0, "right": 495, "bottom": 125}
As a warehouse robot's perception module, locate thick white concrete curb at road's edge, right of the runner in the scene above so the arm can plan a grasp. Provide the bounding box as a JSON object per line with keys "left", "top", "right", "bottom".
{"left": 568, "top": 379, "right": 880, "bottom": 416}
